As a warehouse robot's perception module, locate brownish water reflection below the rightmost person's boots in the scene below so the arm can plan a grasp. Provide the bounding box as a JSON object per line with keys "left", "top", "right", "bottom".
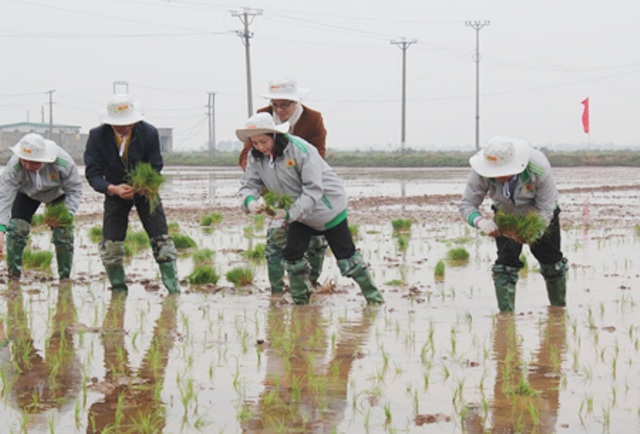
{"left": 466, "top": 307, "right": 566, "bottom": 434}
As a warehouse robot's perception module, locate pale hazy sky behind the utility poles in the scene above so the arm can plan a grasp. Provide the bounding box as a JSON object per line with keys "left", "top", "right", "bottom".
{"left": 0, "top": 0, "right": 640, "bottom": 150}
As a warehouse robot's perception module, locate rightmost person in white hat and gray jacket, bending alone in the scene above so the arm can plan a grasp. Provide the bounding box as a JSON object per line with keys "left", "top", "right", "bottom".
{"left": 460, "top": 137, "right": 567, "bottom": 312}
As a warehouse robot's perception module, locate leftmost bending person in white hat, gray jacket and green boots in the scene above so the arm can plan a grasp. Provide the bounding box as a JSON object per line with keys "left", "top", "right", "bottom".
{"left": 0, "top": 133, "right": 82, "bottom": 279}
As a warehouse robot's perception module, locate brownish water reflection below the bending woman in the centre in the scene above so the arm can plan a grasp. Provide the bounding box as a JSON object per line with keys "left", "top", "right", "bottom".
{"left": 242, "top": 305, "right": 377, "bottom": 433}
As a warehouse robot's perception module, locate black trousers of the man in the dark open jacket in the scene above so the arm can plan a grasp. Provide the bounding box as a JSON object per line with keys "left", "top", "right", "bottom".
{"left": 102, "top": 194, "right": 167, "bottom": 241}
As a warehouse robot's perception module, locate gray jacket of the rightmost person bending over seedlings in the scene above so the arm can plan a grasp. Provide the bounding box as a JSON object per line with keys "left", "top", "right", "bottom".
{"left": 460, "top": 149, "right": 558, "bottom": 226}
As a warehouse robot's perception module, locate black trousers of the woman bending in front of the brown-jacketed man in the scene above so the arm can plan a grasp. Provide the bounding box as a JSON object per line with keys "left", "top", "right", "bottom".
{"left": 282, "top": 219, "right": 356, "bottom": 262}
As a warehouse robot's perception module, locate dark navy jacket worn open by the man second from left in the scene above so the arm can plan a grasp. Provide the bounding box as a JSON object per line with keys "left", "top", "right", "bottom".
{"left": 84, "top": 121, "right": 164, "bottom": 193}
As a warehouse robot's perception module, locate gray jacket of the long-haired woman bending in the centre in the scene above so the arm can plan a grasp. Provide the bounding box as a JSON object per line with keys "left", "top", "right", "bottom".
{"left": 240, "top": 134, "right": 347, "bottom": 231}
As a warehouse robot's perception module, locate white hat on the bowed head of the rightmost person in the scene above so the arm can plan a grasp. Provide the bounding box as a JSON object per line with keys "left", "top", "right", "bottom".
{"left": 469, "top": 137, "right": 531, "bottom": 178}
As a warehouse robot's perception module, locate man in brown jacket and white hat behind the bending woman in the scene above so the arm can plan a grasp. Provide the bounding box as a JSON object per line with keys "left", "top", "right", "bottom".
{"left": 239, "top": 77, "right": 327, "bottom": 294}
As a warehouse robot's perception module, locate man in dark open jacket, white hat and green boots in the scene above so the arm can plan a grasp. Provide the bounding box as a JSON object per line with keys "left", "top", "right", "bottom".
{"left": 84, "top": 95, "right": 180, "bottom": 293}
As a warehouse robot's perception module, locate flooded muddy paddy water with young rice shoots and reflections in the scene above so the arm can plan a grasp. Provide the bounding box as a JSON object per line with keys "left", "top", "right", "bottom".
{"left": 0, "top": 168, "right": 640, "bottom": 433}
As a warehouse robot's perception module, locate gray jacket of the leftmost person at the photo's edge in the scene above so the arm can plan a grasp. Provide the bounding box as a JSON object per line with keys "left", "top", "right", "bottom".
{"left": 0, "top": 146, "right": 82, "bottom": 226}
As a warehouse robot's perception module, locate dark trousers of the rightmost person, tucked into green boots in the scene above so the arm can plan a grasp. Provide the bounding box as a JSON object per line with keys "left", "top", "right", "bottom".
{"left": 495, "top": 208, "right": 564, "bottom": 268}
